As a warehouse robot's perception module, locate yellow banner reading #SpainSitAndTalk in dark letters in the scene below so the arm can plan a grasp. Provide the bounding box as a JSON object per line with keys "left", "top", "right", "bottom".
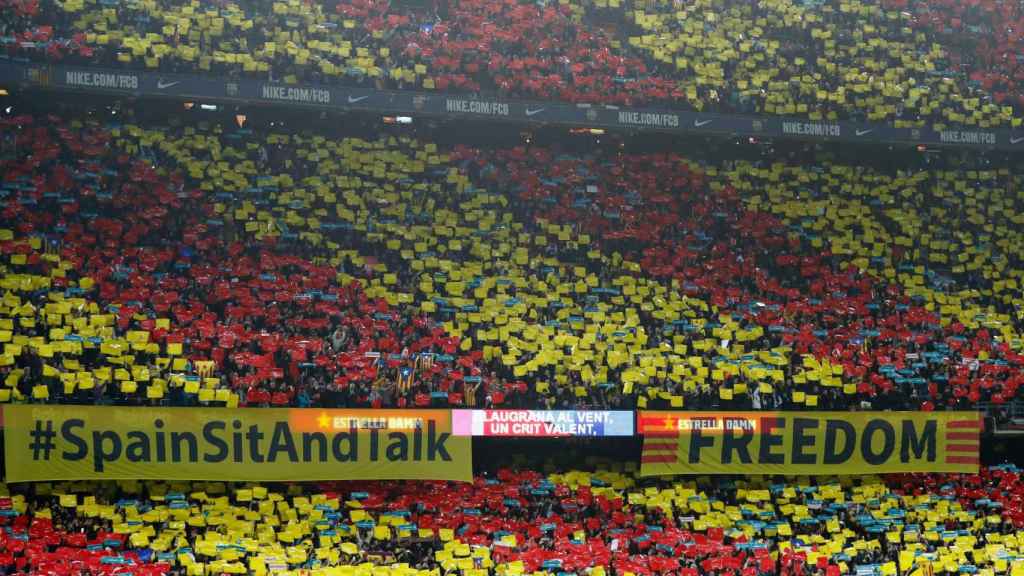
{"left": 3, "top": 406, "right": 472, "bottom": 482}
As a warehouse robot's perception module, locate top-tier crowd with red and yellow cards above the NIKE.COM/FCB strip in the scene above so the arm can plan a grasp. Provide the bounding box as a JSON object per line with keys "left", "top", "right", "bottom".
{"left": 0, "top": 0, "right": 1022, "bottom": 129}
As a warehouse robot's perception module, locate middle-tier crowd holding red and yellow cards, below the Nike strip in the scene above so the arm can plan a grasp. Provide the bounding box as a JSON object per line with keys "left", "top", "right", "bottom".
{"left": 0, "top": 109, "right": 1024, "bottom": 410}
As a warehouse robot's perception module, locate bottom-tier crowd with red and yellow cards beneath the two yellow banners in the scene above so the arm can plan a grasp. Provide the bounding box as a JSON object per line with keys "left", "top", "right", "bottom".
{"left": 0, "top": 464, "right": 1024, "bottom": 576}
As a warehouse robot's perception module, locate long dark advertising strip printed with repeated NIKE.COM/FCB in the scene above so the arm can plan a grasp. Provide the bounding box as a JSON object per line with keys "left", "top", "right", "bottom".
{"left": 0, "top": 59, "right": 1024, "bottom": 150}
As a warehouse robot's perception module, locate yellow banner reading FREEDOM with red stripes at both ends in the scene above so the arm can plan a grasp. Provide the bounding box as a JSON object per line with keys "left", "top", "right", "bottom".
{"left": 637, "top": 412, "right": 981, "bottom": 476}
